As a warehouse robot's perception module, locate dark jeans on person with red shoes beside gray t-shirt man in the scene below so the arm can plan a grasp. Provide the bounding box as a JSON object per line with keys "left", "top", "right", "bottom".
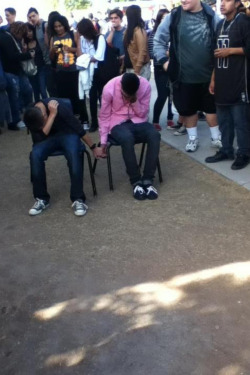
{"left": 153, "top": 65, "right": 174, "bottom": 123}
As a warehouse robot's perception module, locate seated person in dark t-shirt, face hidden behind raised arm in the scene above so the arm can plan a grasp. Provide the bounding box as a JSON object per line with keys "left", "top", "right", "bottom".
{"left": 24, "top": 98, "right": 102, "bottom": 216}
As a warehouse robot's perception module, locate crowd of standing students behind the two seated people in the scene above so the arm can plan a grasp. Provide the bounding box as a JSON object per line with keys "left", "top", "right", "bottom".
{"left": 0, "top": 0, "right": 250, "bottom": 214}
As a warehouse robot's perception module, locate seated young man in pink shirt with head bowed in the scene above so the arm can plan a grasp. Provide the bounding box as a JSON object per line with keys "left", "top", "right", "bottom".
{"left": 99, "top": 73, "right": 160, "bottom": 200}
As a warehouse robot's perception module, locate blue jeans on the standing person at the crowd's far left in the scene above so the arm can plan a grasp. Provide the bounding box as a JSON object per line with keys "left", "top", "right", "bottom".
{"left": 5, "top": 73, "right": 33, "bottom": 124}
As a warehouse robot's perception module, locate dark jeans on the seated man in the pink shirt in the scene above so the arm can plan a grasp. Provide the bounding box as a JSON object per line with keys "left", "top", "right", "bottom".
{"left": 111, "top": 122, "right": 161, "bottom": 185}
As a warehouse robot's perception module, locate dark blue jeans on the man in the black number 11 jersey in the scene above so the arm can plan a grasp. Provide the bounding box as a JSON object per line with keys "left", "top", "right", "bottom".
{"left": 217, "top": 103, "right": 250, "bottom": 156}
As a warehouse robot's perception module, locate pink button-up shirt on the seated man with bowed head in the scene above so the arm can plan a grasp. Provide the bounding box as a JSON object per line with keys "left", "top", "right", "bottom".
{"left": 99, "top": 76, "right": 151, "bottom": 144}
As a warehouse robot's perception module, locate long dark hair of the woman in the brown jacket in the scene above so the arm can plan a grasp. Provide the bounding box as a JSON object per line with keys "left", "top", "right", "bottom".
{"left": 124, "top": 5, "right": 144, "bottom": 46}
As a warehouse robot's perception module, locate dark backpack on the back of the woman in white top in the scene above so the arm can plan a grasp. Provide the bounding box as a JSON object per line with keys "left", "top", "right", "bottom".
{"left": 94, "top": 35, "right": 120, "bottom": 85}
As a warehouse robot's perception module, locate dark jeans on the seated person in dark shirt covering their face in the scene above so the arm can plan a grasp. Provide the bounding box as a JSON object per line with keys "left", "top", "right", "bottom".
{"left": 30, "top": 134, "right": 86, "bottom": 202}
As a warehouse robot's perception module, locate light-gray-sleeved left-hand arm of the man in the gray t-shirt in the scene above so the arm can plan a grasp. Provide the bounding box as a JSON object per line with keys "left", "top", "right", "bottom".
{"left": 153, "top": 13, "right": 171, "bottom": 70}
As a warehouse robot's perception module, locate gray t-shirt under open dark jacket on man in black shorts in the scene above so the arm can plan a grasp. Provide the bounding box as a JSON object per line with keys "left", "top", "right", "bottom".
{"left": 178, "top": 10, "right": 213, "bottom": 83}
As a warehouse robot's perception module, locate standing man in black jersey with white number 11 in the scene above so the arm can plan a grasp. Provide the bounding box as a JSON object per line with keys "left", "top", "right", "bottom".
{"left": 205, "top": 0, "right": 250, "bottom": 170}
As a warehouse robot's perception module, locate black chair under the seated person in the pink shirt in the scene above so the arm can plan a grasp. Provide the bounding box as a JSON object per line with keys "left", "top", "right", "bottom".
{"left": 93, "top": 135, "right": 163, "bottom": 190}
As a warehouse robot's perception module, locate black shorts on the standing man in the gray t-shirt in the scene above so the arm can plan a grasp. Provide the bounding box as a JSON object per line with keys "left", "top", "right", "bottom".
{"left": 173, "top": 82, "right": 216, "bottom": 116}
